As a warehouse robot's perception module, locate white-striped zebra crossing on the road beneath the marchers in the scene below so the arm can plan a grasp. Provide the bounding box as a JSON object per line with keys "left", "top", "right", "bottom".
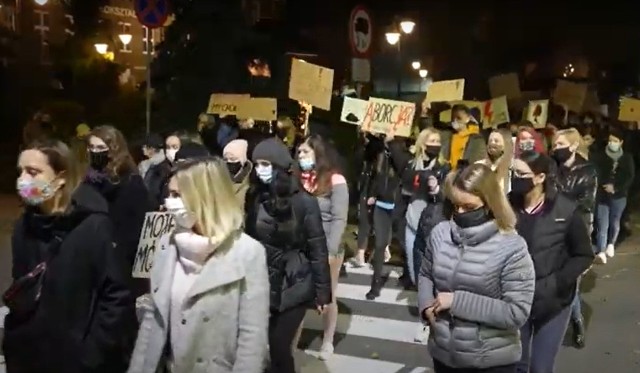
{"left": 296, "top": 267, "right": 432, "bottom": 373}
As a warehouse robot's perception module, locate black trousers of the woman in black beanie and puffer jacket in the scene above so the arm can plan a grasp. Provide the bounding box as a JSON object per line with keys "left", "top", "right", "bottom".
{"left": 267, "top": 306, "right": 307, "bottom": 373}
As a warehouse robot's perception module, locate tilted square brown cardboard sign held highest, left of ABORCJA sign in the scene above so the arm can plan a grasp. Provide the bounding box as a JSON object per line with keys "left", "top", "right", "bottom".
{"left": 289, "top": 58, "right": 333, "bottom": 110}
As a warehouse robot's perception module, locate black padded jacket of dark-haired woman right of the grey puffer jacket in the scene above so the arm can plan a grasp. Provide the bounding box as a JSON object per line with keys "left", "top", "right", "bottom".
{"left": 510, "top": 193, "right": 593, "bottom": 326}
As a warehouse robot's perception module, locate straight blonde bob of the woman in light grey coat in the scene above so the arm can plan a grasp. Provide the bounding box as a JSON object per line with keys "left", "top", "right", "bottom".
{"left": 173, "top": 157, "right": 244, "bottom": 244}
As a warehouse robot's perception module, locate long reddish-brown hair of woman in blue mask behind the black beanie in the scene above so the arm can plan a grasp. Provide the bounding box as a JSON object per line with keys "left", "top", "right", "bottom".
{"left": 294, "top": 134, "right": 341, "bottom": 196}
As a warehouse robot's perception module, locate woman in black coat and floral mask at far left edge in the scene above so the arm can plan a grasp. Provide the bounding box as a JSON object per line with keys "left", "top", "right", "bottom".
{"left": 3, "top": 140, "right": 136, "bottom": 373}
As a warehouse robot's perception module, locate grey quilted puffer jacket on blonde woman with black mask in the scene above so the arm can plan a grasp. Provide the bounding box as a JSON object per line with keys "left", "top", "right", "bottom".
{"left": 418, "top": 221, "right": 535, "bottom": 369}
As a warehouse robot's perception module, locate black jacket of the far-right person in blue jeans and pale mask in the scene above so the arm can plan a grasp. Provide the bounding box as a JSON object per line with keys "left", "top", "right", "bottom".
{"left": 593, "top": 152, "right": 636, "bottom": 202}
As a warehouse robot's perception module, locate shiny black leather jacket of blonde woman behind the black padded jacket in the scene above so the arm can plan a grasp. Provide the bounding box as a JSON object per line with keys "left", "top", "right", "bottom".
{"left": 556, "top": 154, "right": 598, "bottom": 217}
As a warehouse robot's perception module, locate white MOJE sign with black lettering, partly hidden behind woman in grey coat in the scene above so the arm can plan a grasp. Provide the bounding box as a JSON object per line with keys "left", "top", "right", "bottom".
{"left": 132, "top": 212, "right": 176, "bottom": 278}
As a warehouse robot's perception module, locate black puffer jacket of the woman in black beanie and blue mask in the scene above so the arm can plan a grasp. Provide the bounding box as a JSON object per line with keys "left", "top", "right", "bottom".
{"left": 245, "top": 175, "right": 331, "bottom": 312}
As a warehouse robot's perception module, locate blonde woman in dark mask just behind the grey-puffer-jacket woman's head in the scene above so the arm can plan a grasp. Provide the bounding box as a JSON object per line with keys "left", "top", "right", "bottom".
{"left": 477, "top": 129, "right": 513, "bottom": 193}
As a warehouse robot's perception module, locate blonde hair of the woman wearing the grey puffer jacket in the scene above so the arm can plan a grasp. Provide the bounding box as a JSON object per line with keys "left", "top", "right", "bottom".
{"left": 444, "top": 163, "right": 516, "bottom": 232}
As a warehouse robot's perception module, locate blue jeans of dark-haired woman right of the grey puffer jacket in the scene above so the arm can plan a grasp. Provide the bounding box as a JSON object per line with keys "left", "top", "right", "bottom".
{"left": 517, "top": 307, "right": 571, "bottom": 373}
